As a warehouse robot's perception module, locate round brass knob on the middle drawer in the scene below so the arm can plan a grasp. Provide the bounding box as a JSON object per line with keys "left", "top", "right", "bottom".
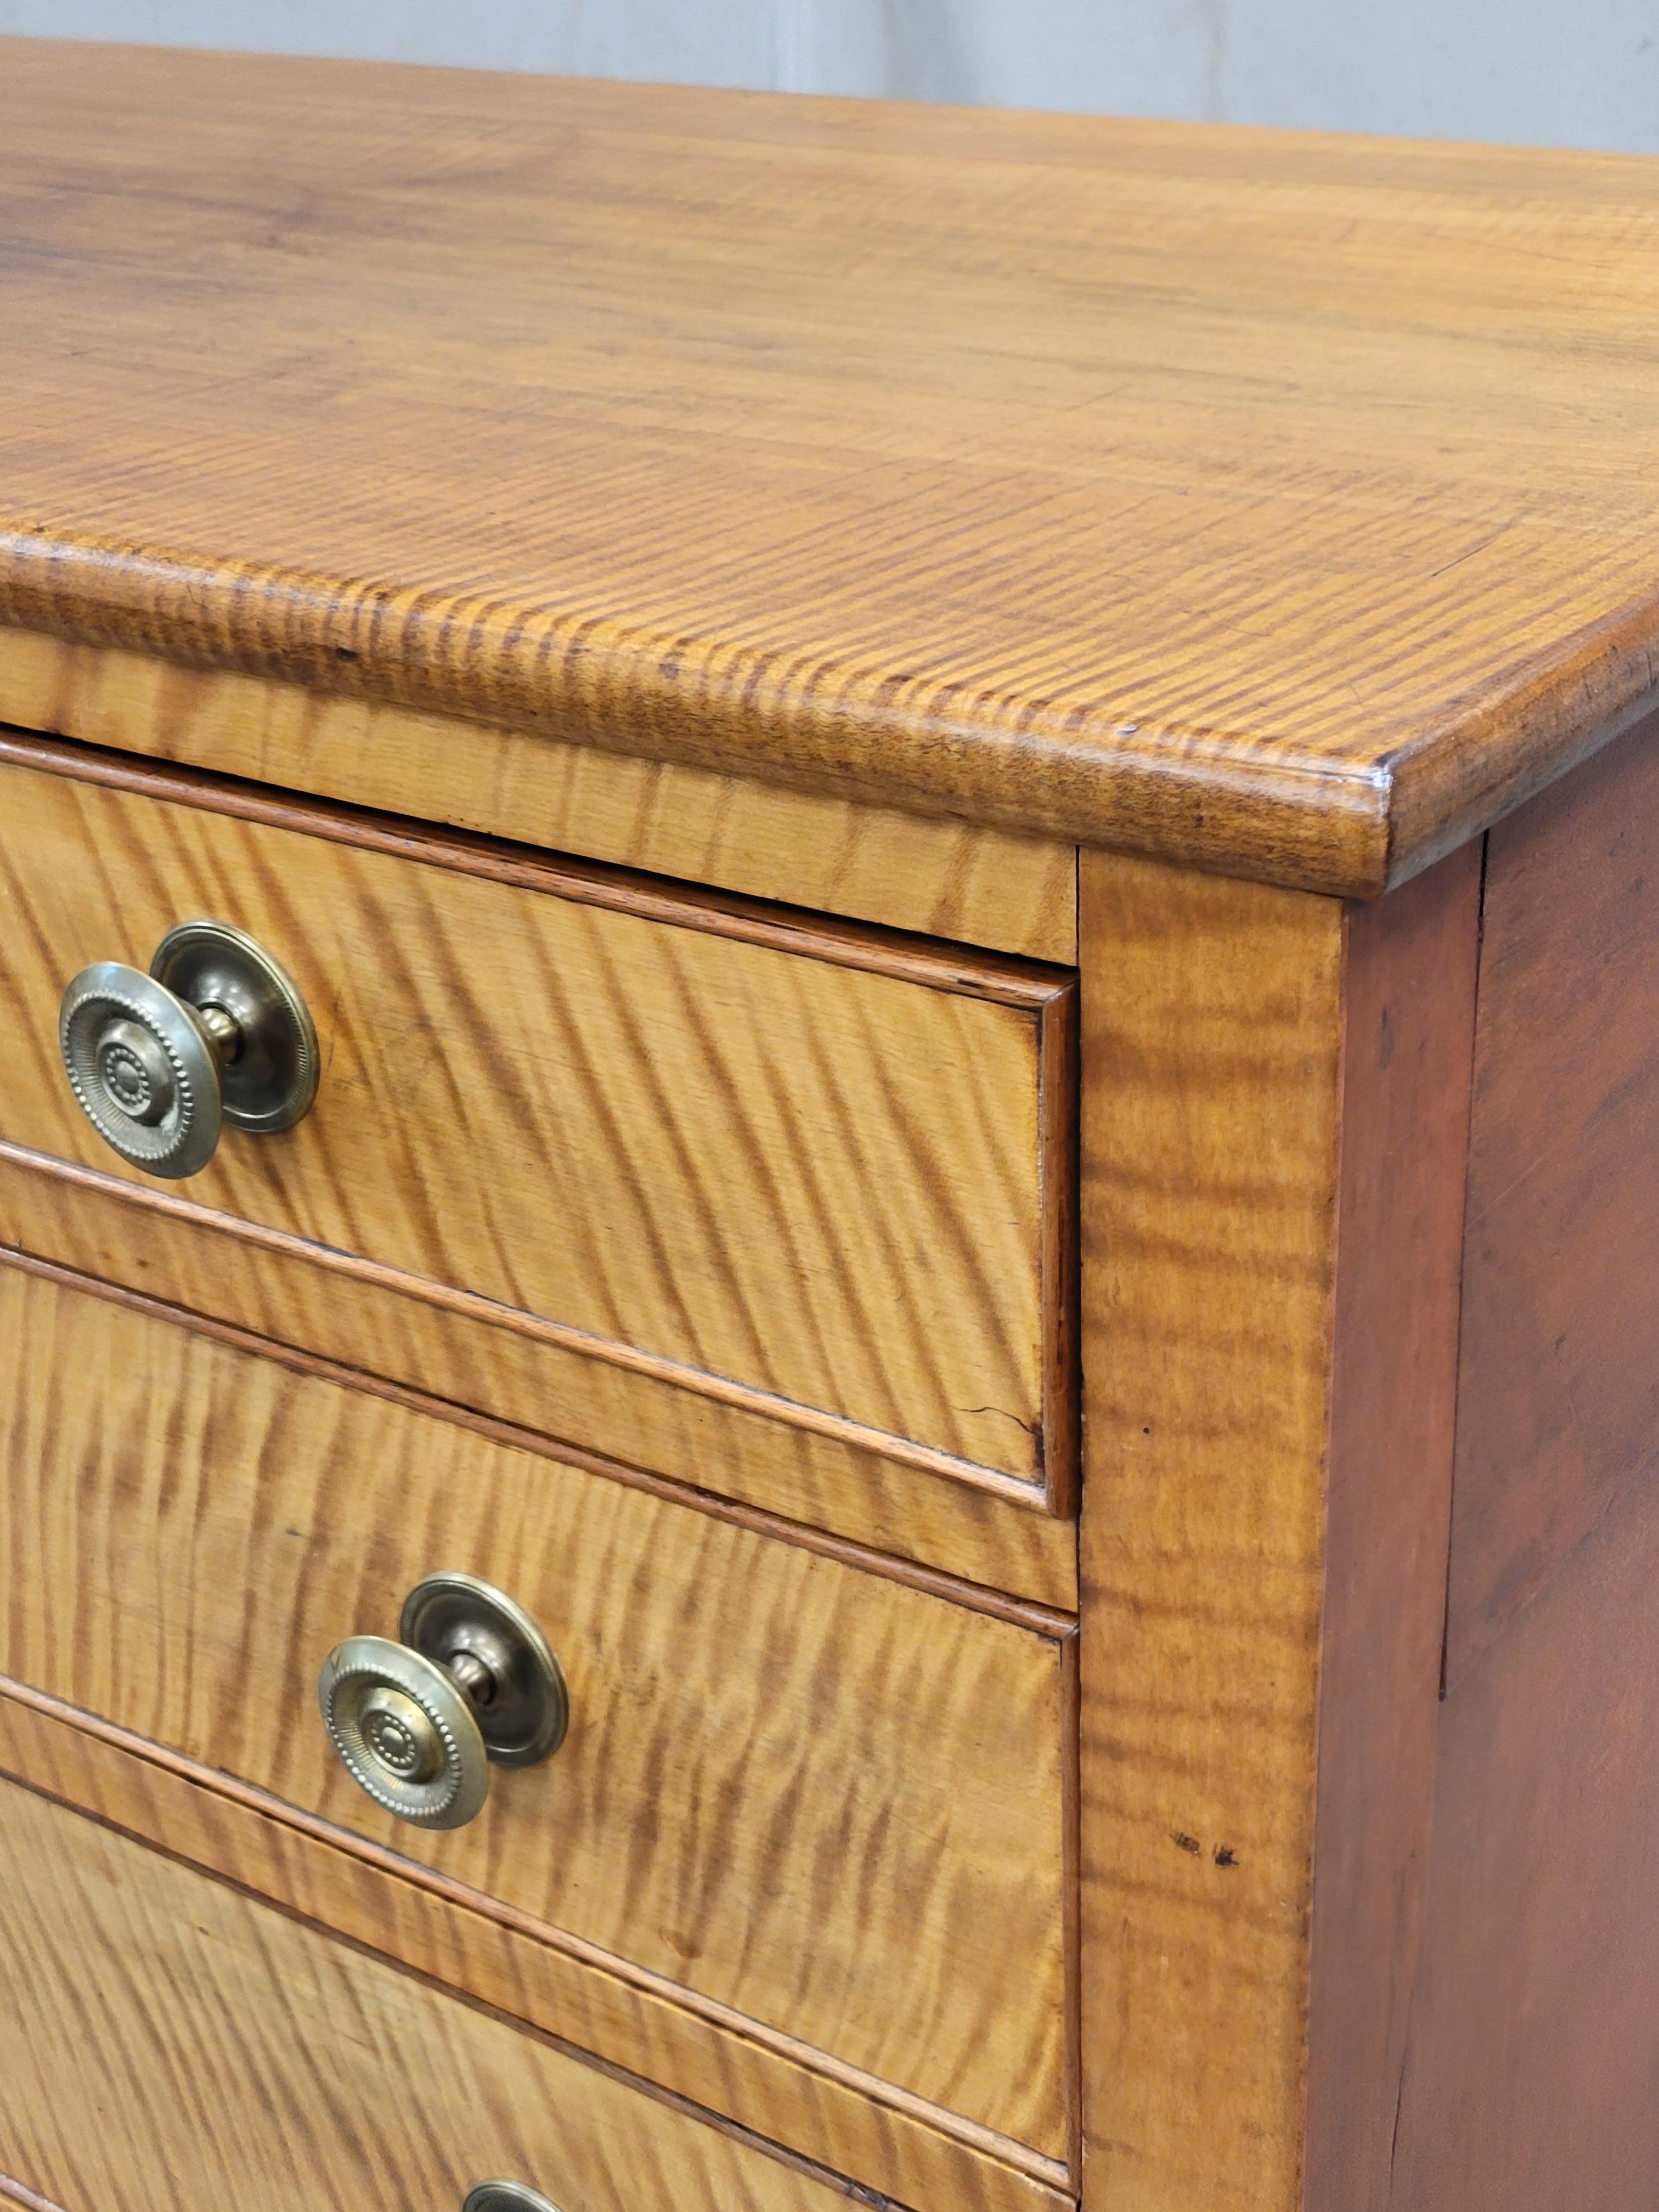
{"left": 317, "top": 1575, "right": 571, "bottom": 1827}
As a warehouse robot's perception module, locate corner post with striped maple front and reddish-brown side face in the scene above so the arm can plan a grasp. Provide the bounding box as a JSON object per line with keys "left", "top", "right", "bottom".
{"left": 1082, "top": 851, "right": 1480, "bottom": 2212}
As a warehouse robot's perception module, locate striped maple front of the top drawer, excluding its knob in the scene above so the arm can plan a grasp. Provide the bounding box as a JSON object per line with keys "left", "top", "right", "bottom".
{"left": 0, "top": 746, "right": 1075, "bottom": 1506}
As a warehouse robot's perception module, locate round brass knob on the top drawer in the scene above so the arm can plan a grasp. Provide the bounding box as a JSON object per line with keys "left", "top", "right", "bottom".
{"left": 58, "top": 922, "right": 319, "bottom": 1177}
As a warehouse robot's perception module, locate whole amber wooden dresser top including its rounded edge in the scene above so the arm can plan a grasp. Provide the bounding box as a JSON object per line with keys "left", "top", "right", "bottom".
{"left": 0, "top": 40, "right": 1659, "bottom": 896}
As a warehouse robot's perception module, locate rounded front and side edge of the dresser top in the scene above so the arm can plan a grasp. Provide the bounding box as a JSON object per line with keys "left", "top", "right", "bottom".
{"left": 0, "top": 524, "right": 1659, "bottom": 898}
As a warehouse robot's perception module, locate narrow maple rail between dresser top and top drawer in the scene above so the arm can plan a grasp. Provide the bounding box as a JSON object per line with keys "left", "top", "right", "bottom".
{"left": 0, "top": 628, "right": 1077, "bottom": 967}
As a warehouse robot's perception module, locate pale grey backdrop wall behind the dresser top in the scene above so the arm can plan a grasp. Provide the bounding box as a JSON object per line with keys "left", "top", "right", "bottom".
{"left": 0, "top": 0, "right": 1659, "bottom": 153}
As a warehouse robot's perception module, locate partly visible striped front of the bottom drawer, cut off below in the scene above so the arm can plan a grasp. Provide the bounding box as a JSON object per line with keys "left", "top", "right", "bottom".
{"left": 0, "top": 1783, "right": 845, "bottom": 2212}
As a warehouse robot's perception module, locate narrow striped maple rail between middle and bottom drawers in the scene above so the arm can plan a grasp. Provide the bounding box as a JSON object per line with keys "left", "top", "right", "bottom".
{"left": 0, "top": 1681, "right": 1070, "bottom": 2212}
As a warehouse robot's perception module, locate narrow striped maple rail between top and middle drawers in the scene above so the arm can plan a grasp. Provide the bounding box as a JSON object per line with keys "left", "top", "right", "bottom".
{"left": 0, "top": 1139, "right": 1077, "bottom": 1612}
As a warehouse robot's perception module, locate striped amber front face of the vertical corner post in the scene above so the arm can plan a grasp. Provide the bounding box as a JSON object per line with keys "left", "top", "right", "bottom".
{"left": 1080, "top": 854, "right": 1342, "bottom": 2212}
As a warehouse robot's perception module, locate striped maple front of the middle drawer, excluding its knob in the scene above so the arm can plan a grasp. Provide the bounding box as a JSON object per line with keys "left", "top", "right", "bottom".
{"left": 0, "top": 1265, "right": 1070, "bottom": 2161}
